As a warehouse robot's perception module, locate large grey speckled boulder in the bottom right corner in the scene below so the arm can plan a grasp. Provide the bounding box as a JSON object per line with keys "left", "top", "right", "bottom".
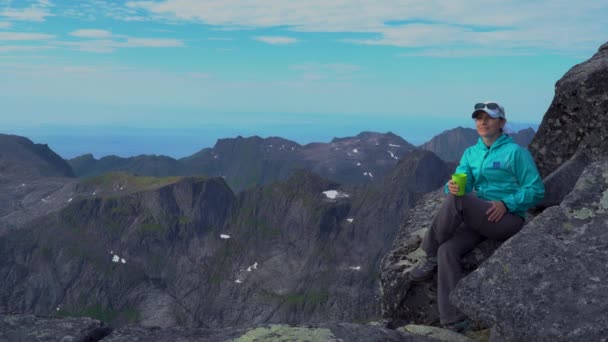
{"left": 451, "top": 161, "right": 608, "bottom": 341}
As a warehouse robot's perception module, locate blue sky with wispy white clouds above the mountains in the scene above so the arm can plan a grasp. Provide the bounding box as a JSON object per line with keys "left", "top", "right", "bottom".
{"left": 0, "top": 0, "right": 608, "bottom": 158}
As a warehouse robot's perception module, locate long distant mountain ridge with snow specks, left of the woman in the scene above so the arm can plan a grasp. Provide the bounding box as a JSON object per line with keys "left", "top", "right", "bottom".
{"left": 69, "top": 132, "right": 415, "bottom": 192}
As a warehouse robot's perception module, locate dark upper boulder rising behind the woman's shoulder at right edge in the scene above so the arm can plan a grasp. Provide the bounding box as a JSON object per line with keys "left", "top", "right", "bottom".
{"left": 529, "top": 43, "right": 608, "bottom": 178}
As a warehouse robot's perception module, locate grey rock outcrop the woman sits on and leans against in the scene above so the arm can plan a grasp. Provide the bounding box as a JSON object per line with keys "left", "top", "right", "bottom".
{"left": 381, "top": 39, "right": 608, "bottom": 341}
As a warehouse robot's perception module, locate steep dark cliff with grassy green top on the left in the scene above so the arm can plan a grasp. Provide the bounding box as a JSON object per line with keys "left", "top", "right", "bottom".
{"left": 0, "top": 179, "right": 234, "bottom": 325}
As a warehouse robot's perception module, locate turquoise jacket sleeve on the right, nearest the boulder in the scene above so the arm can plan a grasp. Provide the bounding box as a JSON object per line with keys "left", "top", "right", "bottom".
{"left": 502, "top": 148, "right": 545, "bottom": 211}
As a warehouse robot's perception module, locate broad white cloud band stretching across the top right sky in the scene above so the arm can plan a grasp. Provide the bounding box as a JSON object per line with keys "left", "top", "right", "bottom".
{"left": 126, "top": 0, "right": 608, "bottom": 54}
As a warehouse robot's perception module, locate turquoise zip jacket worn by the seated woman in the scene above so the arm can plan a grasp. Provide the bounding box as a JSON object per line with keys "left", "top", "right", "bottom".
{"left": 445, "top": 134, "right": 545, "bottom": 219}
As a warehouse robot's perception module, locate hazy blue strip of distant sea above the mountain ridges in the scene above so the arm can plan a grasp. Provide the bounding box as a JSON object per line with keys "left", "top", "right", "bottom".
{"left": 0, "top": 116, "right": 538, "bottom": 159}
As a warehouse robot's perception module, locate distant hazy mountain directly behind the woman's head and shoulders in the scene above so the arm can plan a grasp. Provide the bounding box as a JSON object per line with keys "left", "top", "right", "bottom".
{"left": 419, "top": 127, "right": 534, "bottom": 162}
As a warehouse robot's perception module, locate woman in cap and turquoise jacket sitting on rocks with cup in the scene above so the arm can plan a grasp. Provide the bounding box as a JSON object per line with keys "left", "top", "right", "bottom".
{"left": 409, "top": 102, "right": 545, "bottom": 331}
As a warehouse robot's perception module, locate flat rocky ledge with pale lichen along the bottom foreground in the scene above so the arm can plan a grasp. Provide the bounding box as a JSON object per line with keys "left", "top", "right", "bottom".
{"left": 0, "top": 314, "right": 468, "bottom": 342}
